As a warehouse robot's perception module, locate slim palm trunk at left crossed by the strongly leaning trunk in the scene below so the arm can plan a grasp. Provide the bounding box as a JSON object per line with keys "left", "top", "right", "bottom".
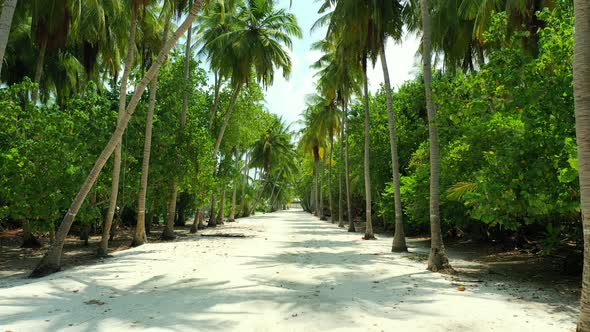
{"left": 97, "top": 5, "right": 137, "bottom": 257}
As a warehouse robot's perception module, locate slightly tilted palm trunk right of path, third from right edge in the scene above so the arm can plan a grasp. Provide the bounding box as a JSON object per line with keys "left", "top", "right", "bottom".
{"left": 381, "top": 47, "right": 408, "bottom": 252}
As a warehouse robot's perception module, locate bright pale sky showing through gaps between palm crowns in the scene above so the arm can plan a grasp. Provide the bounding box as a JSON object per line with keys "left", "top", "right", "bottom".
{"left": 266, "top": 0, "right": 419, "bottom": 129}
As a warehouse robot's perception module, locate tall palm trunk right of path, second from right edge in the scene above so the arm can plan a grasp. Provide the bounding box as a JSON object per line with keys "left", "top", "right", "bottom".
{"left": 420, "top": 0, "right": 451, "bottom": 272}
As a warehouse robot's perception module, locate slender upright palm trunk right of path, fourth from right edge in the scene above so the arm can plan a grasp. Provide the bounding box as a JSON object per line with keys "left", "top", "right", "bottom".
{"left": 363, "top": 56, "right": 375, "bottom": 240}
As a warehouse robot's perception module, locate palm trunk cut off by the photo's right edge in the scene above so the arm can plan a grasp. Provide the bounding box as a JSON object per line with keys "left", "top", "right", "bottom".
{"left": 574, "top": 0, "right": 590, "bottom": 332}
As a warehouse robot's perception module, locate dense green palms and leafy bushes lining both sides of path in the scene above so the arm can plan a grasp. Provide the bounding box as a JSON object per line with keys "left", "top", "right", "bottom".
{"left": 0, "top": 0, "right": 590, "bottom": 331}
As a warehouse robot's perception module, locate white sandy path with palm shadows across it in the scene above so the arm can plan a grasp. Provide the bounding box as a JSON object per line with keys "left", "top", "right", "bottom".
{"left": 0, "top": 211, "right": 577, "bottom": 332}
